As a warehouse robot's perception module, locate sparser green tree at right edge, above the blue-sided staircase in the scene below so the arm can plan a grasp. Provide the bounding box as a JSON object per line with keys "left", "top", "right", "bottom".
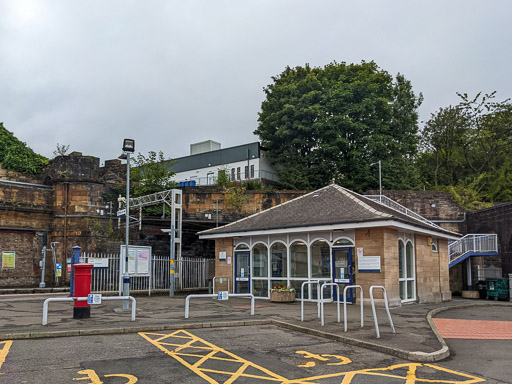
{"left": 418, "top": 92, "right": 512, "bottom": 210}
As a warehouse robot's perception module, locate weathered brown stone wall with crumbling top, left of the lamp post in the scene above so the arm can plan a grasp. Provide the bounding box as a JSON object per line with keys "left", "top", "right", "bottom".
{"left": 0, "top": 153, "right": 122, "bottom": 287}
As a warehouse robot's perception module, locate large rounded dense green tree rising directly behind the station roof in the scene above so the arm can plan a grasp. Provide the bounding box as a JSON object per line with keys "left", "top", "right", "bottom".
{"left": 254, "top": 62, "right": 422, "bottom": 192}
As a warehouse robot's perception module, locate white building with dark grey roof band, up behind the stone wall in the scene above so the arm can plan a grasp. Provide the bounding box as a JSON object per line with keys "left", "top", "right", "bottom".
{"left": 170, "top": 140, "right": 278, "bottom": 186}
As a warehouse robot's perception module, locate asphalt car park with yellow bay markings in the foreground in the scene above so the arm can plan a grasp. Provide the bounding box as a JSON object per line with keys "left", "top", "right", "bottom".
{"left": 0, "top": 325, "right": 488, "bottom": 384}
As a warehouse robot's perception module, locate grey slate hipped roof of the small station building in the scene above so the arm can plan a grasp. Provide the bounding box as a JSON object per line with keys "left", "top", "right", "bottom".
{"left": 199, "top": 184, "right": 458, "bottom": 237}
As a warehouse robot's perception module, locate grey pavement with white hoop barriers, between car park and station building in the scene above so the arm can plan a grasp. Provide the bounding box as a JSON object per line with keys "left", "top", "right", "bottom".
{"left": 0, "top": 290, "right": 512, "bottom": 362}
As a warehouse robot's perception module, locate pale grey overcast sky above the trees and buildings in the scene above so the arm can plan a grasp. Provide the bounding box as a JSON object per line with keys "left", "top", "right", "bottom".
{"left": 0, "top": 0, "right": 512, "bottom": 162}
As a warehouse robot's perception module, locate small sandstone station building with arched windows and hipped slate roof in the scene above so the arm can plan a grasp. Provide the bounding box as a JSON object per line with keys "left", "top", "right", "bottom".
{"left": 199, "top": 184, "right": 459, "bottom": 306}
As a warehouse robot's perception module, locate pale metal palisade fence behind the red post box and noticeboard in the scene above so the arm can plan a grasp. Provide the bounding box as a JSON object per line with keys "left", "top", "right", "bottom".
{"left": 80, "top": 253, "right": 210, "bottom": 293}
